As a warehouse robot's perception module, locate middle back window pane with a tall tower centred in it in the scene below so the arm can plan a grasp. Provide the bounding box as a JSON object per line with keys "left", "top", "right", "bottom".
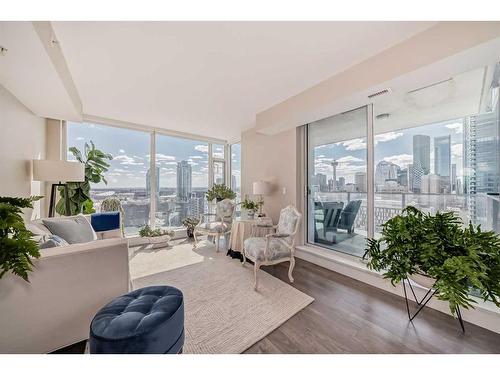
{"left": 155, "top": 135, "right": 208, "bottom": 228}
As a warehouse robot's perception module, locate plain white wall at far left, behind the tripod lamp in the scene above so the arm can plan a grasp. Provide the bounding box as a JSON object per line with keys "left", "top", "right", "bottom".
{"left": 0, "top": 86, "right": 46, "bottom": 217}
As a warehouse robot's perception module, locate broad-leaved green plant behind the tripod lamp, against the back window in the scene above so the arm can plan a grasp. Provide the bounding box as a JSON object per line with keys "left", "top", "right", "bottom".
{"left": 56, "top": 141, "right": 113, "bottom": 216}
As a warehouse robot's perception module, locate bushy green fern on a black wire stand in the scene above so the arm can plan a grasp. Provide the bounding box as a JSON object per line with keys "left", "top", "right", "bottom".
{"left": 363, "top": 206, "right": 500, "bottom": 315}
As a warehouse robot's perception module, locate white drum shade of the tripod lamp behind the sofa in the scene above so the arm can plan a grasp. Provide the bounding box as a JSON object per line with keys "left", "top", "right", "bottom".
{"left": 33, "top": 160, "right": 85, "bottom": 182}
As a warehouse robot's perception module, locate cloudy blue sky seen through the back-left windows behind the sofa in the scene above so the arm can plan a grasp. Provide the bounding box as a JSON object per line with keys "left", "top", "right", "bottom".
{"left": 68, "top": 123, "right": 230, "bottom": 188}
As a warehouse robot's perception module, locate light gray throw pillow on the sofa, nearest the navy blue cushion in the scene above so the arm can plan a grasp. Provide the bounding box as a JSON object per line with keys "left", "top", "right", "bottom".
{"left": 42, "top": 215, "right": 97, "bottom": 244}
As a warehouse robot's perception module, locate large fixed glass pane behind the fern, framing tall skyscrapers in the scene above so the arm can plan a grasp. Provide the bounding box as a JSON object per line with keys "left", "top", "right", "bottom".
{"left": 374, "top": 64, "right": 500, "bottom": 234}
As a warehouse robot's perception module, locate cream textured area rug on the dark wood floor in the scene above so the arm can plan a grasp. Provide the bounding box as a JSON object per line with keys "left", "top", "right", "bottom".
{"left": 130, "top": 243, "right": 314, "bottom": 354}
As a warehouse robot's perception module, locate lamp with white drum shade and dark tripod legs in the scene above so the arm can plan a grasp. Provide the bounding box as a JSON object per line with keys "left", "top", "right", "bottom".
{"left": 33, "top": 160, "right": 85, "bottom": 217}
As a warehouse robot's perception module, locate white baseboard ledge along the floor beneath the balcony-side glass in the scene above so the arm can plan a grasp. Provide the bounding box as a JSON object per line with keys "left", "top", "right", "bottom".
{"left": 295, "top": 245, "right": 500, "bottom": 334}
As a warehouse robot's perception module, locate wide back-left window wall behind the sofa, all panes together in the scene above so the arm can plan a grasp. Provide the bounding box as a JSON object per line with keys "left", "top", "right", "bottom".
{"left": 66, "top": 122, "right": 229, "bottom": 236}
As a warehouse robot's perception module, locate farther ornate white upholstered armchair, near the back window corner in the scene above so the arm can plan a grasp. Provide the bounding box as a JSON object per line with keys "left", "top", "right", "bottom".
{"left": 193, "top": 199, "right": 235, "bottom": 252}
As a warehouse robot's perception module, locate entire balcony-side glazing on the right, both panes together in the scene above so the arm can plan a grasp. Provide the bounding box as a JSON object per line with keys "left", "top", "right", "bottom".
{"left": 307, "top": 64, "right": 500, "bottom": 256}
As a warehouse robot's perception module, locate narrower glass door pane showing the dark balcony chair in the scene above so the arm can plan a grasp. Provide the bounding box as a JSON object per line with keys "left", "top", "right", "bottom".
{"left": 307, "top": 107, "right": 368, "bottom": 256}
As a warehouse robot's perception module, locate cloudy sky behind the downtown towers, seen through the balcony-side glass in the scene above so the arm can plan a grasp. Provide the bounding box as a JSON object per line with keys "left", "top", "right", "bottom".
{"left": 311, "top": 120, "right": 463, "bottom": 183}
